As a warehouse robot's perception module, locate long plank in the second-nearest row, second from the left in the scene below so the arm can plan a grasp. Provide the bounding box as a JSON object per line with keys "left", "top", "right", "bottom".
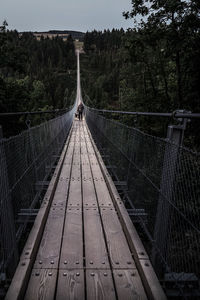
{"left": 59, "top": 207, "right": 83, "bottom": 269}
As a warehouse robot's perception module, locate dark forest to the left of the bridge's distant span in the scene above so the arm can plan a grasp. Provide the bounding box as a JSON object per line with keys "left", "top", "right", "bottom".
{"left": 0, "top": 22, "right": 76, "bottom": 135}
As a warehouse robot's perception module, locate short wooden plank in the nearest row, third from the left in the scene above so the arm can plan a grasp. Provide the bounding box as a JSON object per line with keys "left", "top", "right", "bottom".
{"left": 86, "top": 269, "right": 117, "bottom": 300}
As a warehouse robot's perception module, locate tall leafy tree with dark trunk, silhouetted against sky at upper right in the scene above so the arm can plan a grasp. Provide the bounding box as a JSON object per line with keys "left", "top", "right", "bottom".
{"left": 124, "top": 0, "right": 200, "bottom": 108}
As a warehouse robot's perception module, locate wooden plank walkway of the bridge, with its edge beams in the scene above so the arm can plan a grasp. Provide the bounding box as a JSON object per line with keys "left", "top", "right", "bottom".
{"left": 6, "top": 121, "right": 165, "bottom": 300}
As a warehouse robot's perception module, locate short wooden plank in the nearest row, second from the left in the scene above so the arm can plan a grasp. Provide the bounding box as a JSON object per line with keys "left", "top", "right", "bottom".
{"left": 56, "top": 269, "right": 85, "bottom": 300}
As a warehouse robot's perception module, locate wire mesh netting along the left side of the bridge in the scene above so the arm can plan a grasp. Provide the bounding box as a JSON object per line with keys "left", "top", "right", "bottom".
{"left": 0, "top": 109, "right": 74, "bottom": 276}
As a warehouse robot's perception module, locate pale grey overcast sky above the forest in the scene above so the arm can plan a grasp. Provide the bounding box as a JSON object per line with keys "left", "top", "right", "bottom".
{"left": 0, "top": 0, "right": 133, "bottom": 32}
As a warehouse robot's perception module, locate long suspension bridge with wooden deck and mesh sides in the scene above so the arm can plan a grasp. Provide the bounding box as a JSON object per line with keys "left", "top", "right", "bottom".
{"left": 0, "top": 53, "right": 200, "bottom": 300}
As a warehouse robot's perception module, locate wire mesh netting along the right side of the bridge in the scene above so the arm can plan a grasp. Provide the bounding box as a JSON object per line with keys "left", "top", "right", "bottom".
{"left": 86, "top": 107, "right": 200, "bottom": 295}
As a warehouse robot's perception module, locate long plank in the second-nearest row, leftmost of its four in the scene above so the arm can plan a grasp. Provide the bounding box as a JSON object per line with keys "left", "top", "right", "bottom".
{"left": 34, "top": 207, "right": 64, "bottom": 269}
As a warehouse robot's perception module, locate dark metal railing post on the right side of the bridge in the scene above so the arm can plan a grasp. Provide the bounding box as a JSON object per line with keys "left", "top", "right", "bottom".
{"left": 152, "top": 111, "right": 188, "bottom": 277}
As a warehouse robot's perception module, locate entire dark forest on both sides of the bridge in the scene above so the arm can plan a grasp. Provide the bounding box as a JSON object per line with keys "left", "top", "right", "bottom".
{"left": 0, "top": 0, "right": 200, "bottom": 150}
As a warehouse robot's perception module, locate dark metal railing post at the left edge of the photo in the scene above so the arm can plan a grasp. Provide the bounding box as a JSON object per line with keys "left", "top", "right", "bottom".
{"left": 0, "top": 125, "right": 19, "bottom": 276}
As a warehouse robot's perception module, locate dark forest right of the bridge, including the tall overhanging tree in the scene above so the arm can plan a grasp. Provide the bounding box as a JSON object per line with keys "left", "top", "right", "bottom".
{"left": 82, "top": 0, "right": 200, "bottom": 148}
